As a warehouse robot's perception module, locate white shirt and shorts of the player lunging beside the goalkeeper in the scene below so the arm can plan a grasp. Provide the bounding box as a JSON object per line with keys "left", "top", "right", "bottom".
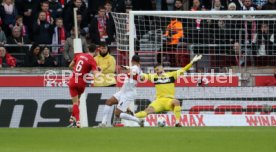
{"left": 114, "top": 65, "right": 142, "bottom": 112}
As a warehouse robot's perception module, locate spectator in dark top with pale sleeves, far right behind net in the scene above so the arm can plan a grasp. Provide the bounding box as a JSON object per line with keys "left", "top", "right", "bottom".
{"left": 253, "top": 22, "right": 275, "bottom": 56}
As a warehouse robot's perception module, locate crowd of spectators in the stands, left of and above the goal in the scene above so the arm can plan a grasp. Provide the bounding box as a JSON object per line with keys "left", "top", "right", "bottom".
{"left": 0, "top": 0, "right": 276, "bottom": 67}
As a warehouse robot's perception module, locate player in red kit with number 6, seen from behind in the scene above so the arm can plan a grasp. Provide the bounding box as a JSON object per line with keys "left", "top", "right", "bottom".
{"left": 68, "top": 50, "right": 99, "bottom": 128}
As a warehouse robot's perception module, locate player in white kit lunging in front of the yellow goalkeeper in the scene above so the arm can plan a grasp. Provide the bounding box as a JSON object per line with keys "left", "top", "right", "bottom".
{"left": 99, "top": 55, "right": 143, "bottom": 127}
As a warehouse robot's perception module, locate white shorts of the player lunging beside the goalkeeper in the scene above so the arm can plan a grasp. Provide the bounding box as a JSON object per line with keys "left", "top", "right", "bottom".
{"left": 113, "top": 91, "right": 136, "bottom": 112}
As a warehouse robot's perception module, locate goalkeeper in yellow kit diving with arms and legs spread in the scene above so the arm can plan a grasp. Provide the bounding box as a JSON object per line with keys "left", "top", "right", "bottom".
{"left": 135, "top": 55, "right": 202, "bottom": 127}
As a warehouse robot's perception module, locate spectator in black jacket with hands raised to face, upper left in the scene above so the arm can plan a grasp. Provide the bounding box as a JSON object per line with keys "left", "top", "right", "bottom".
{"left": 33, "top": 12, "right": 54, "bottom": 44}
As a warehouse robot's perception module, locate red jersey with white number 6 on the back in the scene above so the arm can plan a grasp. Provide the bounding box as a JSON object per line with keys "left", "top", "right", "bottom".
{"left": 70, "top": 53, "right": 97, "bottom": 84}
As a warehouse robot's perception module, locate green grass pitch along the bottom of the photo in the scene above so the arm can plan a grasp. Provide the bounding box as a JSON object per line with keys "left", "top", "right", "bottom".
{"left": 0, "top": 127, "right": 276, "bottom": 152}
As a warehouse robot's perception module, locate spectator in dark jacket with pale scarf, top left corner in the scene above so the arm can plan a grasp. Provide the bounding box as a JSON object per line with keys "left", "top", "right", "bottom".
{"left": 2, "top": 0, "right": 17, "bottom": 35}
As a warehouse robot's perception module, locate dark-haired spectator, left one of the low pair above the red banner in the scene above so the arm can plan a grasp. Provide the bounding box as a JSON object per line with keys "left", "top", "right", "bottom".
{"left": 28, "top": 43, "right": 44, "bottom": 67}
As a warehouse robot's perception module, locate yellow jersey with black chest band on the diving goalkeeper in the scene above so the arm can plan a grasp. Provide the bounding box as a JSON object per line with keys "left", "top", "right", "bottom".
{"left": 143, "top": 64, "right": 192, "bottom": 99}
